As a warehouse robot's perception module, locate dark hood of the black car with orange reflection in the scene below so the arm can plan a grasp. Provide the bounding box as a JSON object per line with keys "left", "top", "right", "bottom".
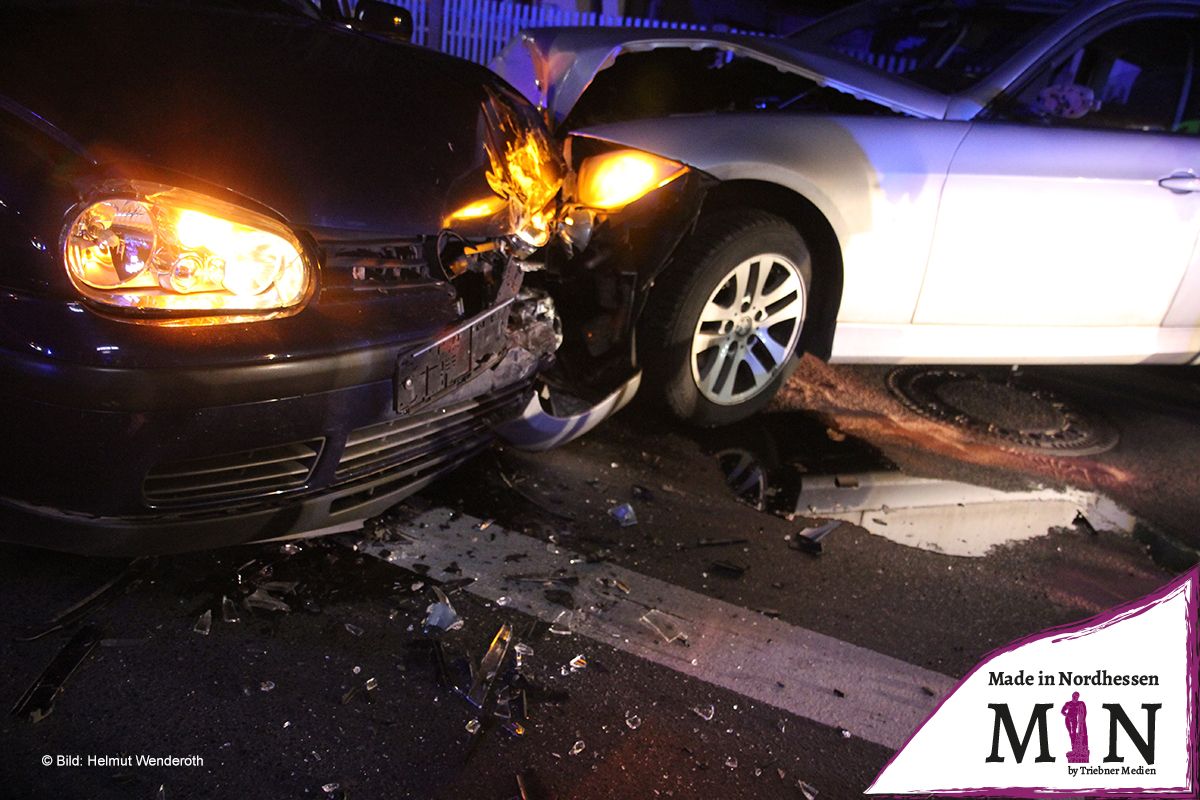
{"left": 0, "top": 0, "right": 533, "bottom": 235}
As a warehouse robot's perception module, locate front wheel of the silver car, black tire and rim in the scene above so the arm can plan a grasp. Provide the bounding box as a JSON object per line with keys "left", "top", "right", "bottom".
{"left": 638, "top": 210, "right": 812, "bottom": 427}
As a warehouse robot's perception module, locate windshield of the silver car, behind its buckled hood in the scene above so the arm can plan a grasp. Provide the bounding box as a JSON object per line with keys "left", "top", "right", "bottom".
{"left": 791, "top": 0, "right": 1069, "bottom": 92}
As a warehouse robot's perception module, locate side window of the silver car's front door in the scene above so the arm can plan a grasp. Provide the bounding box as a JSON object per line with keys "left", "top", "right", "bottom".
{"left": 996, "top": 18, "right": 1200, "bottom": 133}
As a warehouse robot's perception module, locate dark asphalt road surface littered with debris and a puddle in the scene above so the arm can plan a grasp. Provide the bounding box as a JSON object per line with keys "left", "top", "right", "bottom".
{"left": 0, "top": 363, "right": 1200, "bottom": 800}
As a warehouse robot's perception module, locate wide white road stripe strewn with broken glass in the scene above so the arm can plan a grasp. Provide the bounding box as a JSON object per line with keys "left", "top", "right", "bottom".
{"left": 358, "top": 509, "right": 954, "bottom": 750}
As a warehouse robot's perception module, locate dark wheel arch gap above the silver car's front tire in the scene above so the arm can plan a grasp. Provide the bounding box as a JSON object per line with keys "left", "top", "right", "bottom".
{"left": 701, "top": 180, "right": 844, "bottom": 359}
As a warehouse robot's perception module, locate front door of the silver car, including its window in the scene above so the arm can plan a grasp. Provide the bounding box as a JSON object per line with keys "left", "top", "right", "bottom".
{"left": 913, "top": 13, "right": 1200, "bottom": 326}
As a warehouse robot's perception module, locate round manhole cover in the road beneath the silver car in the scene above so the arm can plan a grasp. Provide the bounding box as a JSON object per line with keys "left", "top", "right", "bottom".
{"left": 887, "top": 367, "right": 1118, "bottom": 456}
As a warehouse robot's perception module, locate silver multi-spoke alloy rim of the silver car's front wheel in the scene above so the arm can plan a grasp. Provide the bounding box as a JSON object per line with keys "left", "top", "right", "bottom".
{"left": 691, "top": 253, "right": 805, "bottom": 405}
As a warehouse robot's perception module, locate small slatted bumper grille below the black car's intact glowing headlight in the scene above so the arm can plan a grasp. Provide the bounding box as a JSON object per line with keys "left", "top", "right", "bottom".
{"left": 143, "top": 439, "right": 325, "bottom": 507}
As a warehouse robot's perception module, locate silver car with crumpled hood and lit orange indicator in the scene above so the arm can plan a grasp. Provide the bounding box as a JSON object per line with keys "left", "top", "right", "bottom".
{"left": 492, "top": 0, "right": 1200, "bottom": 425}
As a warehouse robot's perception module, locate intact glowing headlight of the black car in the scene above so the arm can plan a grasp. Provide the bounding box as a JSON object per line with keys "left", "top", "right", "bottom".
{"left": 62, "top": 187, "right": 312, "bottom": 314}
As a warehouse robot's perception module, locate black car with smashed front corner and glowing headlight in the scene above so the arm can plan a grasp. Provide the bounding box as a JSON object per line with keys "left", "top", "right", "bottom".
{"left": 0, "top": 2, "right": 638, "bottom": 554}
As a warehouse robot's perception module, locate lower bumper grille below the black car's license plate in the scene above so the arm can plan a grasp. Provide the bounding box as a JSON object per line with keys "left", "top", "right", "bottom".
{"left": 335, "top": 386, "right": 524, "bottom": 482}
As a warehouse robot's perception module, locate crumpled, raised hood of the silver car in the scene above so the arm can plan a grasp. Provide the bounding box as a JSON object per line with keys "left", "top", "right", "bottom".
{"left": 491, "top": 28, "right": 948, "bottom": 127}
